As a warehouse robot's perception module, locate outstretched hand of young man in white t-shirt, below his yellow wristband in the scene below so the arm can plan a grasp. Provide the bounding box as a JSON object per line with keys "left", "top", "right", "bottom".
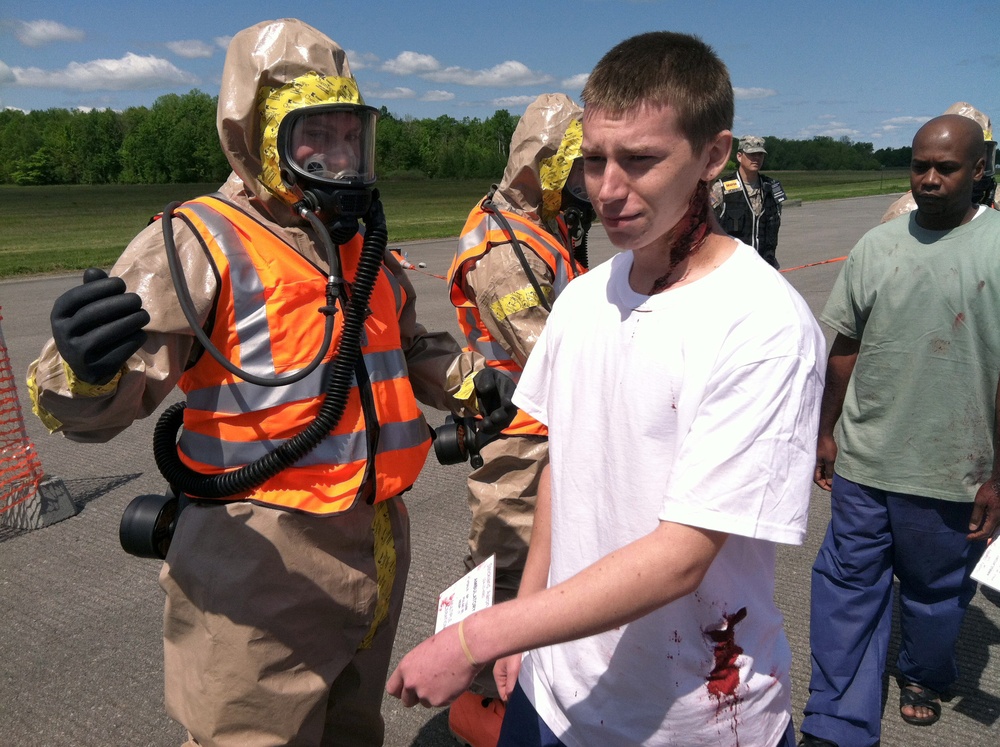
{"left": 385, "top": 625, "right": 482, "bottom": 708}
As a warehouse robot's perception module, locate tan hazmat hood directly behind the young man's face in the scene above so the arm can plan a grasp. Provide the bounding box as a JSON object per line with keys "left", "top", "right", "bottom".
{"left": 493, "top": 93, "right": 583, "bottom": 225}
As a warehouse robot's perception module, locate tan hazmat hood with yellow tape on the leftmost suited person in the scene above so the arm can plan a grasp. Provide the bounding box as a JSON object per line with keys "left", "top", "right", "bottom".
{"left": 217, "top": 18, "right": 364, "bottom": 226}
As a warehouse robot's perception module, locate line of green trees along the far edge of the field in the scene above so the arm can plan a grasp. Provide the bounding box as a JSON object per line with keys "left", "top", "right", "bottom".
{"left": 0, "top": 89, "right": 910, "bottom": 186}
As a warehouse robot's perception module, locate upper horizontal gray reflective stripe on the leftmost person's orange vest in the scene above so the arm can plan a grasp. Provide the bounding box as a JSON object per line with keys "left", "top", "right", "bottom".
{"left": 187, "top": 350, "right": 406, "bottom": 415}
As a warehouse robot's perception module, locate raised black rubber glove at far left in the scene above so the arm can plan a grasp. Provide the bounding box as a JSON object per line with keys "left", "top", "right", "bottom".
{"left": 49, "top": 267, "right": 149, "bottom": 384}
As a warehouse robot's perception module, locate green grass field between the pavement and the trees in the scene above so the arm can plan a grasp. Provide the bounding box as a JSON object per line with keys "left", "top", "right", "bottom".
{"left": 0, "top": 169, "right": 909, "bottom": 278}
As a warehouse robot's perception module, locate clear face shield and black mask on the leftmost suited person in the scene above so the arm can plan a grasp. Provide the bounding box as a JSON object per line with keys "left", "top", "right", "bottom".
{"left": 278, "top": 104, "right": 378, "bottom": 223}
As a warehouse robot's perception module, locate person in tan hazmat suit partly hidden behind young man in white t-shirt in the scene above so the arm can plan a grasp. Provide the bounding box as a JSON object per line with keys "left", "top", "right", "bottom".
{"left": 449, "top": 93, "right": 593, "bottom": 747}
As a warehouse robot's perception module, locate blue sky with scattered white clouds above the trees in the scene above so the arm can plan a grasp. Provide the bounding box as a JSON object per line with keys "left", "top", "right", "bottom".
{"left": 0, "top": 0, "right": 1000, "bottom": 148}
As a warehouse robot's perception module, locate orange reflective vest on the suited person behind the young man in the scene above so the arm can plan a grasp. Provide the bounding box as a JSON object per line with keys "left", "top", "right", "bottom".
{"left": 448, "top": 204, "right": 584, "bottom": 436}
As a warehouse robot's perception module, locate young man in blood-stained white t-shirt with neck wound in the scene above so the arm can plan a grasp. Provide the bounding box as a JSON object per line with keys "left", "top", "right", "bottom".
{"left": 388, "top": 32, "right": 825, "bottom": 747}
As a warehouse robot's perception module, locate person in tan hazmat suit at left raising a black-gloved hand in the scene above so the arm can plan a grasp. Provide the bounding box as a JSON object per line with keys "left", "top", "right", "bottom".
{"left": 29, "top": 19, "right": 513, "bottom": 747}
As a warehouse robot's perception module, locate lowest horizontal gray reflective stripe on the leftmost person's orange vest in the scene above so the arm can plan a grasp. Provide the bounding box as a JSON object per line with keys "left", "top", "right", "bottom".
{"left": 178, "top": 417, "right": 430, "bottom": 468}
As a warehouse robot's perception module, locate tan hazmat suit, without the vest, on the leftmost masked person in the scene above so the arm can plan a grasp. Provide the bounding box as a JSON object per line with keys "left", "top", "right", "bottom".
{"left": 29, "top": 19, "right": 482, "bottom": 747}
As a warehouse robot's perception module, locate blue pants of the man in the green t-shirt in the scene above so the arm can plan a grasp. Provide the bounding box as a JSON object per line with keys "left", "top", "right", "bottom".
{"left": 802, "top": 475, "right": 985, "bottom": 747}
